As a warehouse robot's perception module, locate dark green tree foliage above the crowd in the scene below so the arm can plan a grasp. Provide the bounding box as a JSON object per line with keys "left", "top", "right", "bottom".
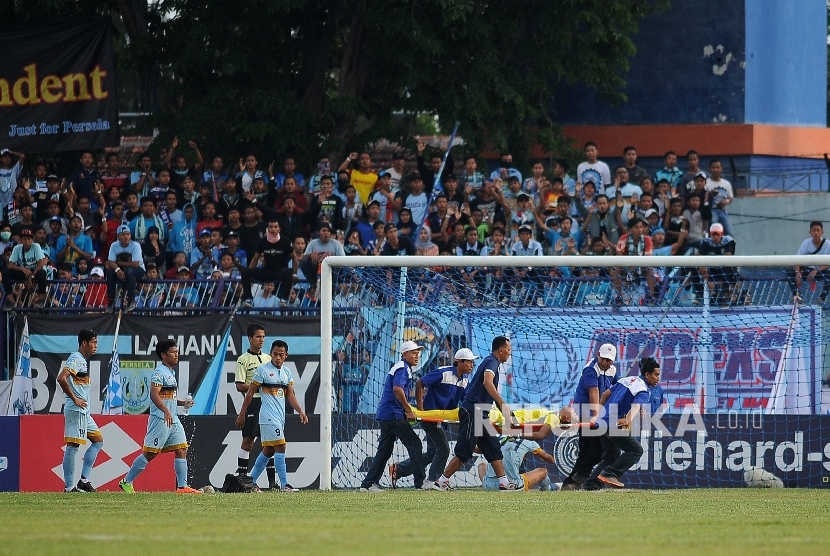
{"left": 0, "top": 0, "right": 667, "bottom": 167}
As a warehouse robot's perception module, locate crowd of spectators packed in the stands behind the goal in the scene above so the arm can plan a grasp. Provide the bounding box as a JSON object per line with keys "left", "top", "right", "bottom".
{"left": 0, "top": 140, "right": 735, "bottom": 310}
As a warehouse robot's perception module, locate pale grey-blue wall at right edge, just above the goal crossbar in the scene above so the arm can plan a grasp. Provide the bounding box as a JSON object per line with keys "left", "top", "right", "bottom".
{"left": 728, "top": 193, "right": 830, "bottom": 255}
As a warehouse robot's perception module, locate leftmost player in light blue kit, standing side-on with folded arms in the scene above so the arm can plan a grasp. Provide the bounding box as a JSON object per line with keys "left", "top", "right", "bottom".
{"left": 57, "top": 329, "right": 104, "bottom": 492}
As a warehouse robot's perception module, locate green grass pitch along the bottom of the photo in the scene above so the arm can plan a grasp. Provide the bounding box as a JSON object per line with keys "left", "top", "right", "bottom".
{"left": 0, "top": 489, "right": 830, "bottom": 556}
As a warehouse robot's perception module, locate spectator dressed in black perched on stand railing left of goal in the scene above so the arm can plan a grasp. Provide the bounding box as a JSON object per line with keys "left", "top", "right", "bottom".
{"left": 240, "top": 218, "right": 296, "bottom": 307}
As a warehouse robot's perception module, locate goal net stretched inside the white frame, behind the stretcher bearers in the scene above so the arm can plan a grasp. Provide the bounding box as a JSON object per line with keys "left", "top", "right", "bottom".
{"left": 320, "top": 256, "right": 830, "bottom": 489}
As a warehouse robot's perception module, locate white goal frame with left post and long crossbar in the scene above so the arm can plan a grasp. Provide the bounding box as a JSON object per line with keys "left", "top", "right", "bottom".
{"left": 320, "top": 255, "right": 830, "bottom": 490}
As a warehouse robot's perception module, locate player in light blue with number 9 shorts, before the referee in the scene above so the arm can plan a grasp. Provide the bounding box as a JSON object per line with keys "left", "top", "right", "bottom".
{"left": 236, "top": 340, "right": 308, "bottom": 492}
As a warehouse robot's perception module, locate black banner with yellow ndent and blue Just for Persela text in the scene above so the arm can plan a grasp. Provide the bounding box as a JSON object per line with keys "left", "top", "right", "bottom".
{"left": 0, "top": 17, "right": 119, "bottom": 152}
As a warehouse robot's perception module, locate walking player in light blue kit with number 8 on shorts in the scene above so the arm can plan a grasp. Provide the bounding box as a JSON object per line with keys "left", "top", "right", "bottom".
{"left": 118, "top": 339, "right": 202, "bottom": 494}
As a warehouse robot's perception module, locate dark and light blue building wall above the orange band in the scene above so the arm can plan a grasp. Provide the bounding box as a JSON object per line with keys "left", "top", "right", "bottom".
{"left": 554, "top": 0, "right": 827, "bottom": 127}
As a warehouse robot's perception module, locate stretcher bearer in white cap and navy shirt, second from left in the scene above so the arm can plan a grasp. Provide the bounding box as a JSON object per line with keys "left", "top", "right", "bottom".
{"left": 389, "top": 348, "right": 478, "bottom": 488}
